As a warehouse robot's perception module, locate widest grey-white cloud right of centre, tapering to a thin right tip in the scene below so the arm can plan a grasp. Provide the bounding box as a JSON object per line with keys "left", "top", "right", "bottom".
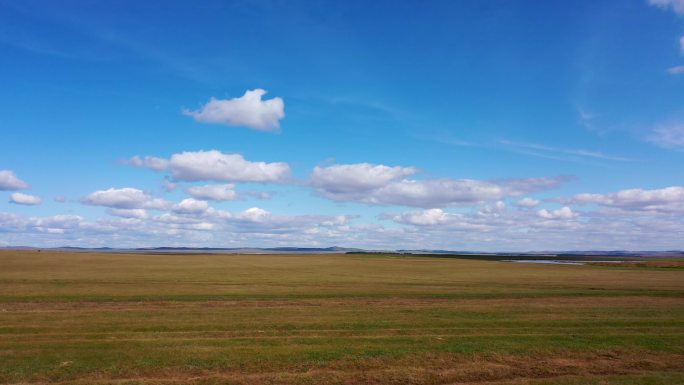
{"left": 311, "top": 163, "right": 565, "bottom": 208}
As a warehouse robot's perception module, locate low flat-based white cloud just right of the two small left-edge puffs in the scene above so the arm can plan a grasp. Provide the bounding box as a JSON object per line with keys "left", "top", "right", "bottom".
{"left": 81, "top": 187, "right": 170, "bottom": 210}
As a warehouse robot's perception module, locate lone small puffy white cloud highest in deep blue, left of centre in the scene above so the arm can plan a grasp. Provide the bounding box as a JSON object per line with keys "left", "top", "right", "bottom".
{"left": 183, "top": 88, "right": 285, "bottom": 131}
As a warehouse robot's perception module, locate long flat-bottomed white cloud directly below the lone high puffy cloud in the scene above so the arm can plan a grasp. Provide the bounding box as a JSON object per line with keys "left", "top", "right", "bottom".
{"left": 126, "top": 150, "right": 290, "bottom": 182}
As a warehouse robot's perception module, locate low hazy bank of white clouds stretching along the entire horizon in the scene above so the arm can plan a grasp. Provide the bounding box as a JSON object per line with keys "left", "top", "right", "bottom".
{"left": 0, "top": 194, "right": 684, "bottom": 251}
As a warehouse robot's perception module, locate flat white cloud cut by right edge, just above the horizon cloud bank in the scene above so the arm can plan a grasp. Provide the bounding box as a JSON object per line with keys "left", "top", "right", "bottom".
{"left": 571, "top": 186, "right": 684, "bottom": 214}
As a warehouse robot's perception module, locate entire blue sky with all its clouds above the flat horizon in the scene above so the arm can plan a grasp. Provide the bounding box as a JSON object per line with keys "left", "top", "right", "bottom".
{"left": 0, "top": 0, "right": 684, "bottom": 251}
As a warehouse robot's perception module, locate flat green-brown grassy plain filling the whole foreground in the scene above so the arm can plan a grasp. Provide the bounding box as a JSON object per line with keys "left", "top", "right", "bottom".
{"left": 0, "top": 251, "right": 684, "bottom": 385}
